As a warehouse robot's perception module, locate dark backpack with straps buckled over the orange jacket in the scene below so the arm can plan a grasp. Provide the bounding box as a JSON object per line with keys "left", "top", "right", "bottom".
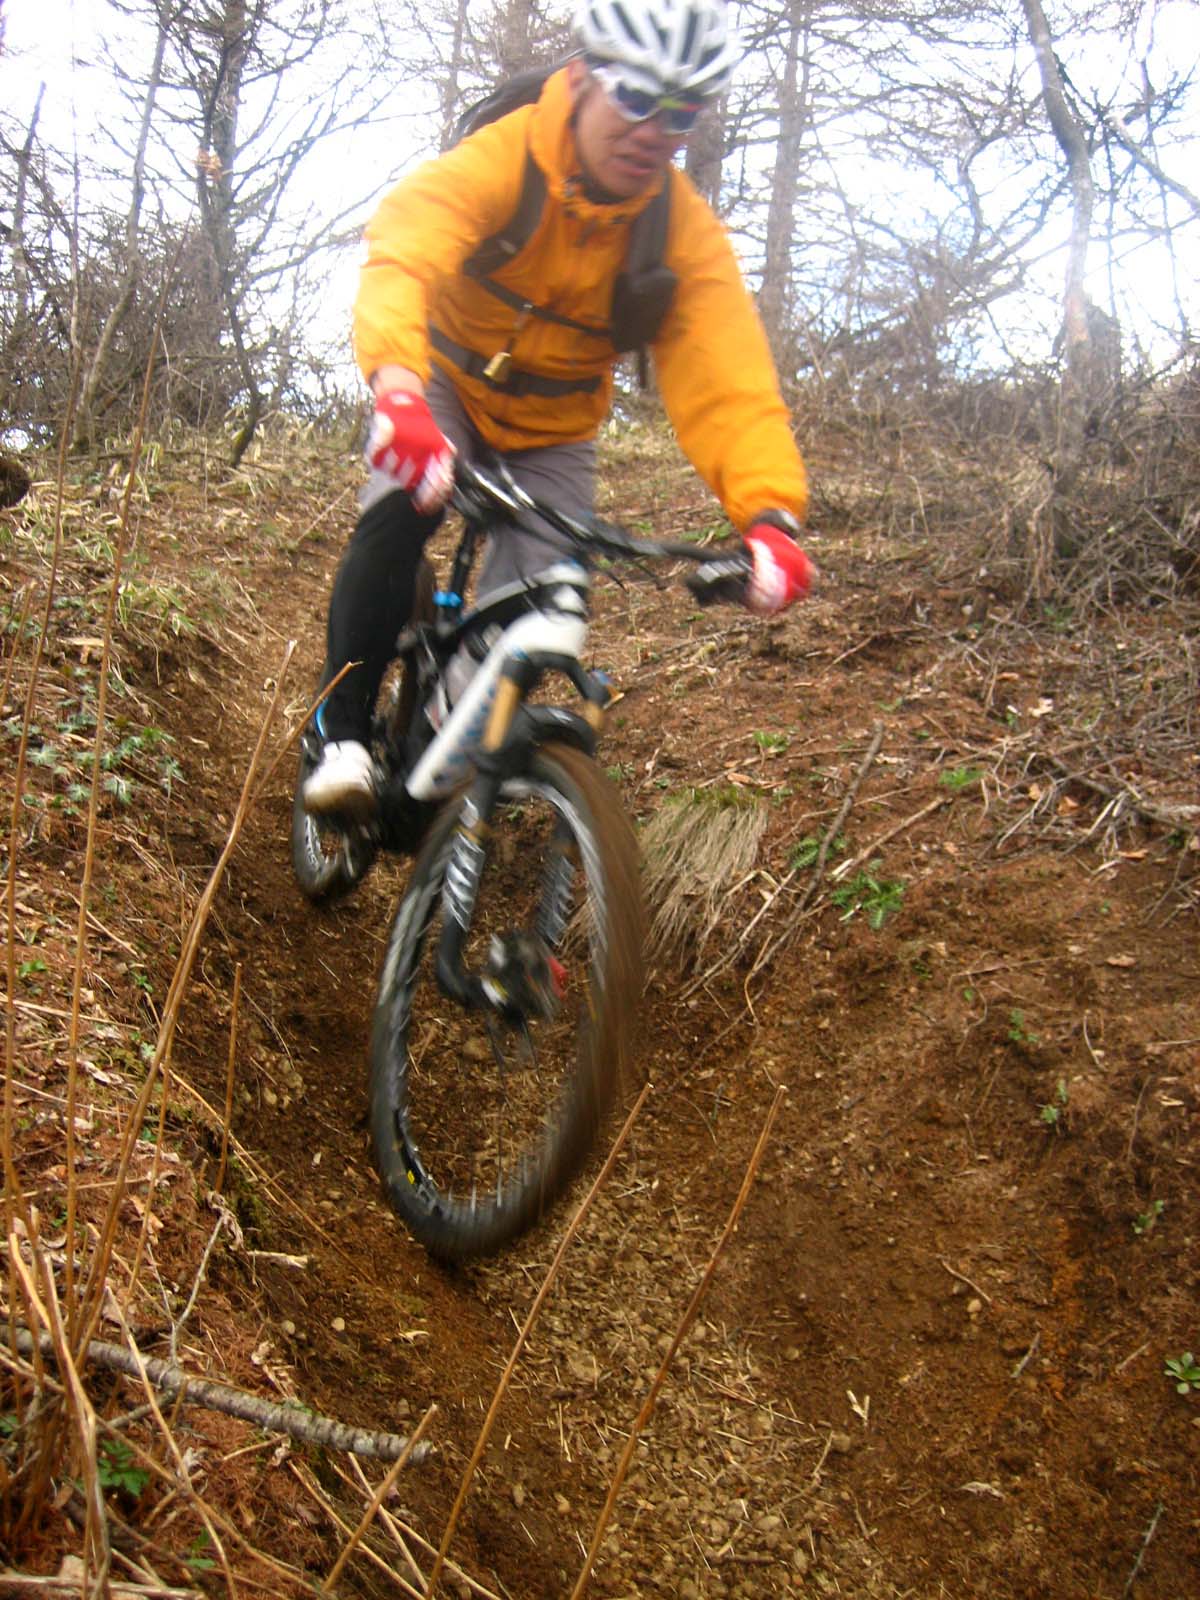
{"left": 451, "top": 61, "right": 678, "bottom": 387}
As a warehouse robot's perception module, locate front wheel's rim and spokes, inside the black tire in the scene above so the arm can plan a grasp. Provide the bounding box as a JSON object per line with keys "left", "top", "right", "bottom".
{"left": 384, "top": 779, "right": 606, "bottom": 1218}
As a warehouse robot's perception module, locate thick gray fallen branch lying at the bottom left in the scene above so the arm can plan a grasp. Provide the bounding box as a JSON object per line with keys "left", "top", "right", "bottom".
{"left": 16, "top": 1328, "right": 429, "bottom": 1461}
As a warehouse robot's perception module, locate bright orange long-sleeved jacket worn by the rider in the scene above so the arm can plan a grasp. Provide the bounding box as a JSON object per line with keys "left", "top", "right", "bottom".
{"left": 354, "top": 72, "right": 808, "bottom": 530}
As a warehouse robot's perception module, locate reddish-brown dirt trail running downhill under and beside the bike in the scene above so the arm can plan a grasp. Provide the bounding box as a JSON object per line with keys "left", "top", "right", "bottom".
{"left": 136, "top": 448, "right": 1200, "bottom": 1600}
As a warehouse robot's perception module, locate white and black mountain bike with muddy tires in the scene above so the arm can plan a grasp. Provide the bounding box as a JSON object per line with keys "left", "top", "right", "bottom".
{"left": 293, "top": 461, "right": 749, "bottom": 1261}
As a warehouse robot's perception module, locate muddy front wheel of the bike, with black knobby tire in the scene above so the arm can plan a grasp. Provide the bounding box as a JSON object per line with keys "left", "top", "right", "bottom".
{"left": 371, "top": 746, "right": 642, "bottom": 1261}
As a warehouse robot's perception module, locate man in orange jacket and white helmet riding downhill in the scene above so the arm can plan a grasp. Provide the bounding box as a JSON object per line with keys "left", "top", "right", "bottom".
{"left": 304, "top": 0, "right": 813, "bottom": 816}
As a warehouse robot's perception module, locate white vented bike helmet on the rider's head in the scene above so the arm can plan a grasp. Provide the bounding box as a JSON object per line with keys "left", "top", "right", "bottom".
{"left": 574, "top": 0, "right": 741, "bottom": 99}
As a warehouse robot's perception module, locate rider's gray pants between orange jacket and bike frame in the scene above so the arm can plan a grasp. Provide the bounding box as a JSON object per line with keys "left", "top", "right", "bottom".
{"left": 360, "top": 368, "right": 595, "bottom": 595}
